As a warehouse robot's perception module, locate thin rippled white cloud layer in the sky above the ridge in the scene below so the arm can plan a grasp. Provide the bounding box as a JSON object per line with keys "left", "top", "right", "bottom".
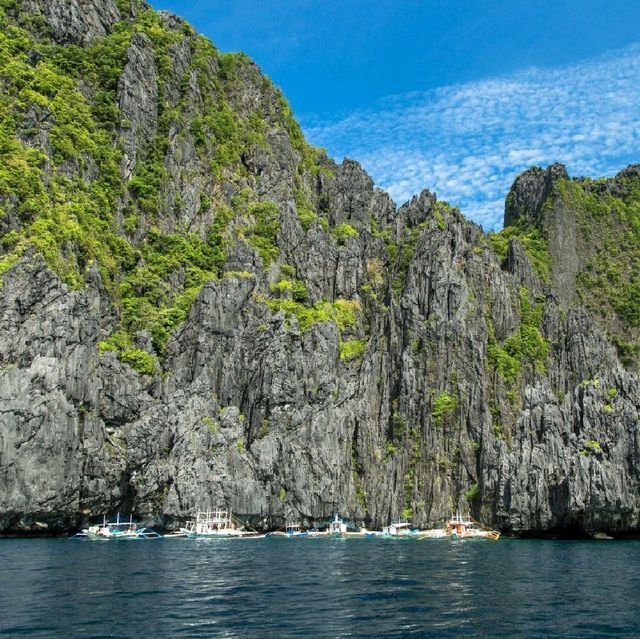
{"left": 302, "top": 44, "right": 640, "bottom": 229}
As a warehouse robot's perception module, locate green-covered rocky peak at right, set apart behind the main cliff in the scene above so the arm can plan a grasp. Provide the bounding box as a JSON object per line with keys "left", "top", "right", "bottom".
{"left": 489, "top": 165, "right": 640, "bottom": 368}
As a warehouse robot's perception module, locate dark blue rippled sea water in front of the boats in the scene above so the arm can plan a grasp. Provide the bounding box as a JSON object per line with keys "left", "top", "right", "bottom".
{"left": 0, "top": 539, "right": 640, "bottom": 638}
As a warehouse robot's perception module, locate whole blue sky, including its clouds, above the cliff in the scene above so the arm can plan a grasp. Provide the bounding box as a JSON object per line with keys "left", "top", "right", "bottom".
{"left": 152, "top": 0, "right": 640, "bottom": 229}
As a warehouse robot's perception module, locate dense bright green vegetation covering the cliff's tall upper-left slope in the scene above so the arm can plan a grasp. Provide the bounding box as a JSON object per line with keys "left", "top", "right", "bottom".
{"left": 0, "top": 0, "right": 348, "bottom": 373}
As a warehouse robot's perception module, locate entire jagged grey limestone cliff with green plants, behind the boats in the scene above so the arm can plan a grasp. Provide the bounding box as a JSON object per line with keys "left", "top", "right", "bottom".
{"left": 0, "top": 0, "right": 640, "bottom": 533}
